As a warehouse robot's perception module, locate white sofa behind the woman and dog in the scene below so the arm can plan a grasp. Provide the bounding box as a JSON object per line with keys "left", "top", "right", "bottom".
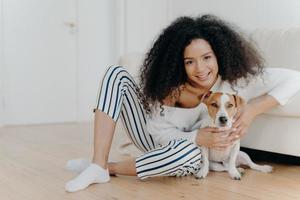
{"left": 117, "top": 28, "right": 300, "bottom": 157}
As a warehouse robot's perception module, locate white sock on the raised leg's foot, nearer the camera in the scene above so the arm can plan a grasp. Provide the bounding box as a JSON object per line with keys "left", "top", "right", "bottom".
{"left": 65, "top": 163, "right": 110, "bottom": 192}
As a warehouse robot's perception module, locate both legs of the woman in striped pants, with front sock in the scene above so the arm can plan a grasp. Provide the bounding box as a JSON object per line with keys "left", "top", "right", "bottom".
{"left": 66, "top": 67, "right": 201, "bottom": 192}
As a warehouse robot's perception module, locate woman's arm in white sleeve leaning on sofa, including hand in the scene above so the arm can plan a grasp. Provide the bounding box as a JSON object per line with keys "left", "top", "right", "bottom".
{"left": 233, "top": 68, "right": 300, "bottom": 137}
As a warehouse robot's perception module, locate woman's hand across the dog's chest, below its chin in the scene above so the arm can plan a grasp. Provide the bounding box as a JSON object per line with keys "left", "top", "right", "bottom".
{"left": 196, "top": 127, "right": 238, "bottom": 150}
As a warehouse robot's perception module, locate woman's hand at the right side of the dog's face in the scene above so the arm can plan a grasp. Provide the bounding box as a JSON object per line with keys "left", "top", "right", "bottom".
{"left": 231, "top": 104, "right": 256, "bottom": 138}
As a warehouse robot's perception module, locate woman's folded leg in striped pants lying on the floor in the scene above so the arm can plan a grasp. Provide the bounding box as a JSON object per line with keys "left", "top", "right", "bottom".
{"left": 108, "top": 140, "right": 201, "bottom": 179}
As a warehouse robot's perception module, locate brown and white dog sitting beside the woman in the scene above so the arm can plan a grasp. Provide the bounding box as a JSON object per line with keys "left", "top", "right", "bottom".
{"left": 196, "top": 92, "right": 273, "bottom": 180}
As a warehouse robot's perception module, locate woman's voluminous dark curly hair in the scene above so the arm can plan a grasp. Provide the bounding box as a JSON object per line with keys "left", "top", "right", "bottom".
{"left": 140, "top": 15, "right": 263, "bottom": 112}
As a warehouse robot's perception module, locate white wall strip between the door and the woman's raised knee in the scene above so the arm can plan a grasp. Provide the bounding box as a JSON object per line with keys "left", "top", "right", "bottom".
{"left": 77, "top": 0, "right": 117, "bottom": 121}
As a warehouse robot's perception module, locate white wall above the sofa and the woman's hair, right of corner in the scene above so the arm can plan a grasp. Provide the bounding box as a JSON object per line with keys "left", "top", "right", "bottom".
{"left": 171, "top": 0, "right": 300, "bottom": 30}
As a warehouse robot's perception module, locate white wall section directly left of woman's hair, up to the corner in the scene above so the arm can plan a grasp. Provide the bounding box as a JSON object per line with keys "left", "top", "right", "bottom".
{"left": 119, "top": 0, "right": 170, "bottom": 54}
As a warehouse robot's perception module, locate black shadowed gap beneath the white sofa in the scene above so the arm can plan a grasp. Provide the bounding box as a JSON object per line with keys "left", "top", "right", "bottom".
{"left": 241, "top": 147, "right": 300, "bottom": 165}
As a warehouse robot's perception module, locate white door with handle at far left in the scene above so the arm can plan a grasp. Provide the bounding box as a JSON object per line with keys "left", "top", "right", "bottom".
{"left": 2, "top": 0, "right": 77, "bottom": 124}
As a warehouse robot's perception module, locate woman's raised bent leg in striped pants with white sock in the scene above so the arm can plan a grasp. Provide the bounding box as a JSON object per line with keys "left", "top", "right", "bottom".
{"left": 66, "top": 66, "right": 155, "bottom": 192}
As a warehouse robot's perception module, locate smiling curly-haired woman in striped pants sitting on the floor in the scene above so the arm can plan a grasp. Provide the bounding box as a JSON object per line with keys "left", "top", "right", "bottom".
{"left": 66, "top": 15, "right": 300, "bottom": 192}
